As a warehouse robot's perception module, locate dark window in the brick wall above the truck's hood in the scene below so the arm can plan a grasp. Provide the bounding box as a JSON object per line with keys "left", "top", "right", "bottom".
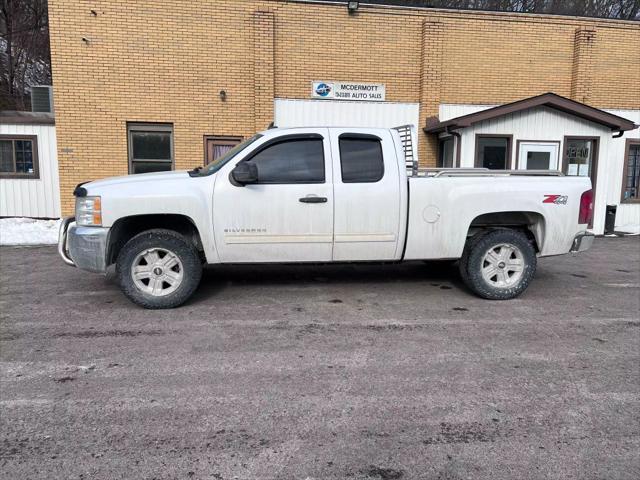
{"left": 127, "top": 123, "right": 173, "bottom": 173}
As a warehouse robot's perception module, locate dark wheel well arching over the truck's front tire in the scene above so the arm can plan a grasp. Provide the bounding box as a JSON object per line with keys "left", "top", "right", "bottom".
{"left": 107, "top": 214, "right": 204, "bottom": 265}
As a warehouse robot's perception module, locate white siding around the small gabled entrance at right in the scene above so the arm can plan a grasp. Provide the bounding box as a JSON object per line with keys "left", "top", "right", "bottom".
{"left": 439, "top": 104, "right": 640, "bottom": 234}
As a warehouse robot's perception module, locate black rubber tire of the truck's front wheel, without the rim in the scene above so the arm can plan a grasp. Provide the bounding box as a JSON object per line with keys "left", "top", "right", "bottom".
{"left": 116, "top": 229, "right": 202, "bottom": 309}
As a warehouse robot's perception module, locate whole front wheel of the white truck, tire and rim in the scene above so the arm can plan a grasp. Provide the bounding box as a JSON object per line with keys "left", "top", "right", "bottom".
{"left": 116, "top": 229, "right": 202, "bottom": 309}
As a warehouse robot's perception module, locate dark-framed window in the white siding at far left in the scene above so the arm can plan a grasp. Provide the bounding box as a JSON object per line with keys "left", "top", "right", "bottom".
{"left": 0, "top": 135, "right": 40, "bottom": 179}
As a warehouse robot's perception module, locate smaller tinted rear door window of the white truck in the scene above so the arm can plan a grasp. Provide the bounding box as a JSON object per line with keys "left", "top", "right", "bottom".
{"left": 340, "top": 135, "right": 384, "bottom": 183}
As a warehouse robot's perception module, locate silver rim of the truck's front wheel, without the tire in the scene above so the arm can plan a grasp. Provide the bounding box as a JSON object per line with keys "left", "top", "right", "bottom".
{"left": 131, "top": 248, "right": 184, "bottom": 297}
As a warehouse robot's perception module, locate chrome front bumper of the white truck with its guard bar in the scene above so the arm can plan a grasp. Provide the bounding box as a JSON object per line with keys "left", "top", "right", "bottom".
{"left": 58, "top": 217, "right": 109, "bottom": 273}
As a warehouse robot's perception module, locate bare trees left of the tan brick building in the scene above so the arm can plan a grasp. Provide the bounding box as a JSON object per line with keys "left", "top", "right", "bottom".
{"left": 0, "top": 0, "right": 51, "bottom": 110}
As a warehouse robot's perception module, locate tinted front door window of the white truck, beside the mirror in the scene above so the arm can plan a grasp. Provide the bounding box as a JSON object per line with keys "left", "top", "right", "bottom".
{"left": 250, "top": 138, "right": 325, "bottom": 183}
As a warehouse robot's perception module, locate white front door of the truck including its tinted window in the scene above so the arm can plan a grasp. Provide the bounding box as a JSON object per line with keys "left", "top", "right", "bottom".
{"left": 213, "top": 128, "right": 334, "bottom": 263}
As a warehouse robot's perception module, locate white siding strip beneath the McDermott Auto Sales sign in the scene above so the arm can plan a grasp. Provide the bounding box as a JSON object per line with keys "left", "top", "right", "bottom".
{"left": 274, "top": 98, "right": 420, "bottom": 128}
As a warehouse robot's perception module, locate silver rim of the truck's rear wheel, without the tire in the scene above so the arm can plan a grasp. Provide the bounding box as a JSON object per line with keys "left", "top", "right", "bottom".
{"left": 482, "top": 243, "right": 524, "bottom": 288}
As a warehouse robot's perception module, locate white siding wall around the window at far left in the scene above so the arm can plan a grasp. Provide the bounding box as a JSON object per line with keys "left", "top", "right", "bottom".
{"left": 0, "top": 124, "right": 60, "bottom": 218}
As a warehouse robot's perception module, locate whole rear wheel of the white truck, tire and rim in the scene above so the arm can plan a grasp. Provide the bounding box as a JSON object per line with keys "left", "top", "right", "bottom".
{"left": 460, "top": 229, "right": 537, "bottom": 300}
